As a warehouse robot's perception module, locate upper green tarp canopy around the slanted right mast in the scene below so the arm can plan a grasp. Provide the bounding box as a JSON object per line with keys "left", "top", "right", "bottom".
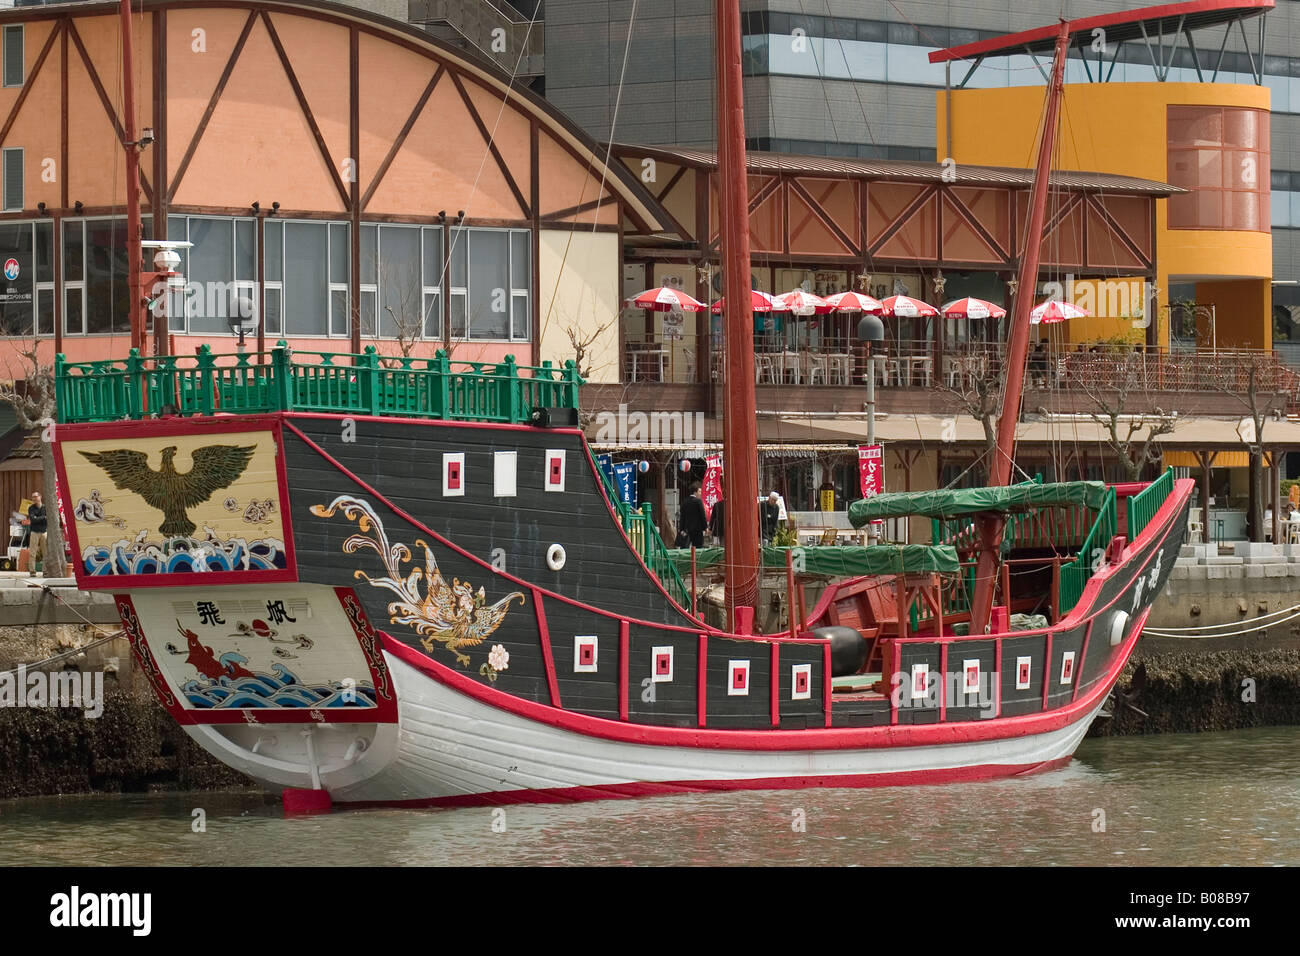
{"left": 849, "top": 481, "right": 1106, "bottom": 528}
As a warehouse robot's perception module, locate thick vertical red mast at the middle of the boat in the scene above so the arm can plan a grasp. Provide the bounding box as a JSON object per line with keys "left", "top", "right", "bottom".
{"left": 715, "top": 0, "right": 759, "bottom": 630}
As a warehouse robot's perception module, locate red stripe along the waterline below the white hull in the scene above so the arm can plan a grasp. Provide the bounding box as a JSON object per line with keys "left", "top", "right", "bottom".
{"left": 335, "top": 757, "right": 1074, "bottom": 809}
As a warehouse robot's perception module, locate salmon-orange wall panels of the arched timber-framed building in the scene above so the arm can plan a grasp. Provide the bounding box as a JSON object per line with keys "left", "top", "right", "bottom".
{"left": 0, "top": 3, "right": 658, "bottom": 377}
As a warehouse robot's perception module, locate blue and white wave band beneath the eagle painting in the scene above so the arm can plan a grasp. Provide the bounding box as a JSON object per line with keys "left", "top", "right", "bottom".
{"left": 82, "top": 537, "right": 289, "bottom": 578}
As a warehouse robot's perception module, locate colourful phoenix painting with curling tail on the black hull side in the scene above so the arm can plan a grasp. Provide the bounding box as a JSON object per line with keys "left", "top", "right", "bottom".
{"left": 311, "top": 494, "right": 525, "bottom": 679}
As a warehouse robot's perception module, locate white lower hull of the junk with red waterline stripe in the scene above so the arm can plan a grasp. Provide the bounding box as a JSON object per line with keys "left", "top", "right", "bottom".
{"left": 187, "top": 654, "right": 1105, "bottom": 805}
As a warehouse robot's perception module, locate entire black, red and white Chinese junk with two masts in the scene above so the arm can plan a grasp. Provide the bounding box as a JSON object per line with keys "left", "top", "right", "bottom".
{"left": 56, "top": 11, "right": 1192, "bottom": 808}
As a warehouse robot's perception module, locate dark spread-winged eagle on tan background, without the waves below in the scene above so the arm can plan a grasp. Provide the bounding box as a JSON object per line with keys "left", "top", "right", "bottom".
{"left": 59, "top": 431, "right": 283, "bottom": 550}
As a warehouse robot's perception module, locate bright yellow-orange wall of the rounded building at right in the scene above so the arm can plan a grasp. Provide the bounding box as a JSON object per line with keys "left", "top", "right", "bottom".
{"left": 935, "top": 83, "right": 1273, "bottom": 349}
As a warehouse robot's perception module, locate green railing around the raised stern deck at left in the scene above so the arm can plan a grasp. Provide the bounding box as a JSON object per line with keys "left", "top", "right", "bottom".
{"left": 55, "top": 342, "right": 582, "bottom": 424}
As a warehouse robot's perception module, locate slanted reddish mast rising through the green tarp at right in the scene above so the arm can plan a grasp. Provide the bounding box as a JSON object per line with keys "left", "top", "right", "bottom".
{"left": 970, "top": 20, "right": 1070, "bottom": 633}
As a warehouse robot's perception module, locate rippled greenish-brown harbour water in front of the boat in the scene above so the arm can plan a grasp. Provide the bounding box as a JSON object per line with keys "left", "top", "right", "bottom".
{"left": 0, "top": 727, "right": 1300, "bottom": 866}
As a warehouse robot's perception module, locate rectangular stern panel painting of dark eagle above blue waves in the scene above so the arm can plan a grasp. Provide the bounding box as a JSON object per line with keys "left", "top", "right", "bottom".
{"left": 61, "top": 431, "right": 287, "bottom": 576}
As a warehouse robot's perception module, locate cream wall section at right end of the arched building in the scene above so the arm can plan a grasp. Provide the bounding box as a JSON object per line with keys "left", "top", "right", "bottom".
{"left": 537, "top": 229, "right": 623, "bottom": 382}
